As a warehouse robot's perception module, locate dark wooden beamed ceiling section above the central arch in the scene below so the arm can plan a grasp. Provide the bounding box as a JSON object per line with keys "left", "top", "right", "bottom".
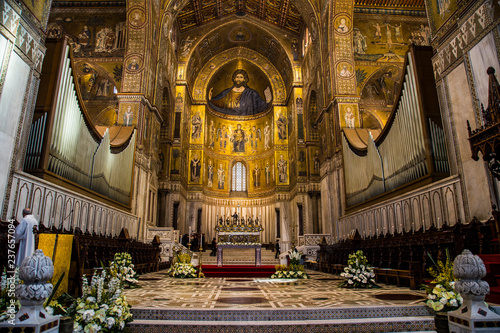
{"left": 177, "top": 0, "right": 304, "bottom": 36}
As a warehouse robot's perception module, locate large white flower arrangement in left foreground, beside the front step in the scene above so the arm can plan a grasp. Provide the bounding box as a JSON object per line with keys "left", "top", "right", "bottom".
{"left": 71, "top": 270, "right": 132, "bottom": 333}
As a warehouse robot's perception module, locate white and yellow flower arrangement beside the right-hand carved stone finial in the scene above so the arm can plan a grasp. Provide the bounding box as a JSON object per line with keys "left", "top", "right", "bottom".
{"left": 423, "top": 249, "right": 463, "bottom": 312}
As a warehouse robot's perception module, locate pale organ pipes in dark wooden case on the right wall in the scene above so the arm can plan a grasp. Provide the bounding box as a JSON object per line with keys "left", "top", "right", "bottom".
{"left": 342, "top": 46, "right": 449, "bottom": 207}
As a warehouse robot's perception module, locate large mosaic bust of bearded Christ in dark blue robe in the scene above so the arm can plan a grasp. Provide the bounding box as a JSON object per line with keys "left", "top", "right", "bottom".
{"left": 208, "top": 69, "right": 273, "bottom": 116}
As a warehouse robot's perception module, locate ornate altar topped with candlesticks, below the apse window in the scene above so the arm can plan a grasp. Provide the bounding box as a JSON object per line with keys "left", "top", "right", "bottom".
{"left": 215, "top": 213, "right": 264, "bottom": 267}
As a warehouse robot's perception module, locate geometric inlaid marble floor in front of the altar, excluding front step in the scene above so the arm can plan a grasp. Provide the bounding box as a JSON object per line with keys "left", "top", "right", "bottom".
{"left": 125, "top": 271, "right": 425, "bottom": 309}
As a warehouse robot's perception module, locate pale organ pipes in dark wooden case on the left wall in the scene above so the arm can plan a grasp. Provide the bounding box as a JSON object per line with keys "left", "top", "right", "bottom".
{"left": 25, "top": 40, "right": 136, "bottom": 205}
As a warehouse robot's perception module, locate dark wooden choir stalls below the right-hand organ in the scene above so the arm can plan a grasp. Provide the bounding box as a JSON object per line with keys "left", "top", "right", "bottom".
{"left": 318, "top": 219, "right": 494, "bottom": 289}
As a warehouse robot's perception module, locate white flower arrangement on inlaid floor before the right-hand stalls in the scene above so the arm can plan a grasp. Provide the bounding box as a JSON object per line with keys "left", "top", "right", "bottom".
{"left": 340, "top": 250, "right": 378, "bottom": 288}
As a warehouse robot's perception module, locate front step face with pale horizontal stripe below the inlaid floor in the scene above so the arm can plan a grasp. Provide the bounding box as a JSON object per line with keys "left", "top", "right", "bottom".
{"left": 130, "top": 306, "right": 434, "bottom": 333}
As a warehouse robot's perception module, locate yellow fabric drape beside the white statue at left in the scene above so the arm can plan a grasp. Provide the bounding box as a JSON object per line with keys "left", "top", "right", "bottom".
{"left": 38, "top": 234, "right": 73, "bottom": 298}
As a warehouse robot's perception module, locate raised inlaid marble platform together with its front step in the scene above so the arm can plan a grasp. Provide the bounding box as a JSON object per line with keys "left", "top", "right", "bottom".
{"left": 125, "top": 272, "right": 442, "bottom": 333}
